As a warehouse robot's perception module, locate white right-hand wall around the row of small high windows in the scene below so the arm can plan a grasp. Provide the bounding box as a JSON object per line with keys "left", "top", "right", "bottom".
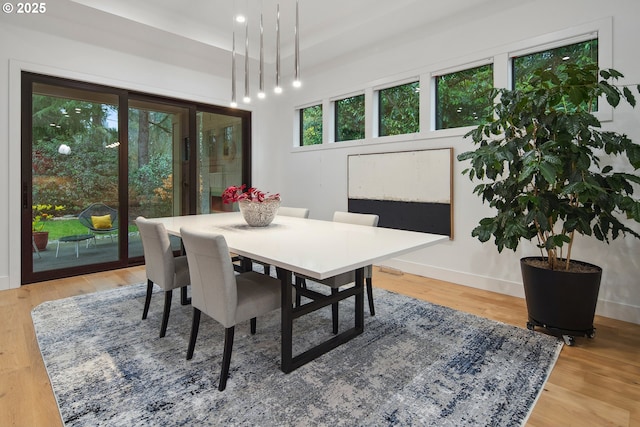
{"left": 254, "top": 0, "right": 640, "bottom": 323}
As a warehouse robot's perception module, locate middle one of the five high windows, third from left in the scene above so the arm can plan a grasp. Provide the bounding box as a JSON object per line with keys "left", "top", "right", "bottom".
{"left": 378, "top": 82, "right": 420, "bottom": 136}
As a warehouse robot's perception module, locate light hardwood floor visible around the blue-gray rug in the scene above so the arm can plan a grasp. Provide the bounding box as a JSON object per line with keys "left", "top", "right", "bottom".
{"left": 0, "top": 267, "right": 640, "bottom": 427}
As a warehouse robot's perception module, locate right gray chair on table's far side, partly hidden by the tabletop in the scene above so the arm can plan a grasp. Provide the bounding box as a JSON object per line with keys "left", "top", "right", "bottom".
{"left": 296, "top": 211, "right": 379, "bottom": 334}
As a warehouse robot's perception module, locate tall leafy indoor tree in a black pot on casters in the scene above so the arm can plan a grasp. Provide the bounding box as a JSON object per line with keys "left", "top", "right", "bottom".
{"left": 458, "top": 64, "right": 640, "bottom": 345}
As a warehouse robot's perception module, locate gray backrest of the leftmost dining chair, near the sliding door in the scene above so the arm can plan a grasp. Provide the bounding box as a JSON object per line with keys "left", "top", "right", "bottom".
{"left": 136, "top": 216, "right": 176, "bottom": 290}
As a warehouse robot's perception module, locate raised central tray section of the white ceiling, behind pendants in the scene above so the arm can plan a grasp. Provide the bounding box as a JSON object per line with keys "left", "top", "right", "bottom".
{"left": 58, "top": 0, "right": 530, "bottom": 65}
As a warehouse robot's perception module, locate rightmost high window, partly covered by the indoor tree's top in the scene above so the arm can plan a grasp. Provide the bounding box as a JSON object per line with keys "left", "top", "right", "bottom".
{"left": 511, "top": 39, "right": 598, "bottom": 89}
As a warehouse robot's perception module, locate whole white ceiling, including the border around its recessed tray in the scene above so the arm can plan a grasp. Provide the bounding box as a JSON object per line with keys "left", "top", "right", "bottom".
{"left": 0, "top": 0, "right": 536, "bottom": 77}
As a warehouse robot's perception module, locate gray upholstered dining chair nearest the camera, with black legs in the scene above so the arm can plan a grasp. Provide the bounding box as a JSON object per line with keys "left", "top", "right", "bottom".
{"left": 180, "top": 227, "right": 281, "bottom": 391}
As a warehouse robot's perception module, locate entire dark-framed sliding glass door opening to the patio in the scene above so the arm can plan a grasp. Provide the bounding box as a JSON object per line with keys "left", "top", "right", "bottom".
{"left": 21, "top": 73, "right": 251, "bottom": 283}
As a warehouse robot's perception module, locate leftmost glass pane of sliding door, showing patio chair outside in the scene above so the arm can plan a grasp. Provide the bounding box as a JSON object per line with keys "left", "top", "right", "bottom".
{"left": 23, "top": 78, "right": 120, "bottom": 273}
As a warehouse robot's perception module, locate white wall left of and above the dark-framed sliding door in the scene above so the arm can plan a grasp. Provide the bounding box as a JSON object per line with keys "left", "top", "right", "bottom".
{"left": 0, "top": 20, "right": 249, "bottom": 290}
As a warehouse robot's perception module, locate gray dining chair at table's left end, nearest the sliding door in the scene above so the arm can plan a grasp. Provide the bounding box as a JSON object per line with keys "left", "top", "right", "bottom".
{"left": 136, "top": 216, "right": 190, "bottom": 338}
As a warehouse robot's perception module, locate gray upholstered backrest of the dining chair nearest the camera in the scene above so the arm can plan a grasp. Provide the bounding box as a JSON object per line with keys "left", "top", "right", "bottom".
{"left": 180, "top": 228, "right": 238, "bottom": 328}
